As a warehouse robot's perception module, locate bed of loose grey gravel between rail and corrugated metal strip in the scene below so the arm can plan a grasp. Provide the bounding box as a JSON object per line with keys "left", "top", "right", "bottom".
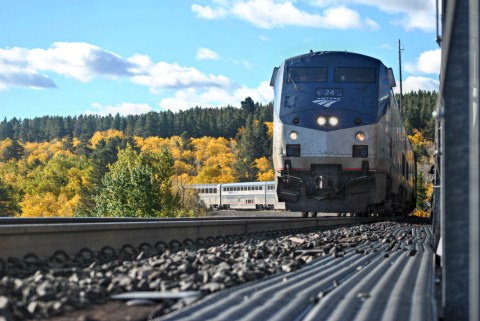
{"left": 0, "top": 222, "right": 428, "bottom": 321}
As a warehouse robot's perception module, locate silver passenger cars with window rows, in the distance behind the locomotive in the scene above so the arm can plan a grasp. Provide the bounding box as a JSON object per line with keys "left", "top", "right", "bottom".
{"left": 190, "top": 181, "right": 285, "bottom": 210}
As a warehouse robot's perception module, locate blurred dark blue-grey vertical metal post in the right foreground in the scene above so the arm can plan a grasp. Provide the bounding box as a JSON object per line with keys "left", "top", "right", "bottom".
{"left": 441, "top": 0, "right": 470, "bottom": 320}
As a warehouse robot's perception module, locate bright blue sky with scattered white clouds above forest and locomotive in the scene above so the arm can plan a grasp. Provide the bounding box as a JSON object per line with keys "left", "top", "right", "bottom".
{"left": 0, "top": 0, "right": 440, "bottom": 119}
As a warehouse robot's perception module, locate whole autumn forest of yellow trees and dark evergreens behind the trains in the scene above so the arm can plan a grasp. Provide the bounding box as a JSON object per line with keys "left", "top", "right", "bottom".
{"left": 0, "top": 91, "right": 437, "bottom": 217}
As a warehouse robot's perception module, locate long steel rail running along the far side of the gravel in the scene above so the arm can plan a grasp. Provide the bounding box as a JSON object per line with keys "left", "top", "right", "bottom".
{"left": 0, "top": 217, "right": 377, "bottom": 259}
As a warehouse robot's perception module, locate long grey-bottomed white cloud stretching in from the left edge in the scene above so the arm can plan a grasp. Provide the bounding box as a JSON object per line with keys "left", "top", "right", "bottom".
{"left": 0, "top": 42, "right": 230, "bottom": 91}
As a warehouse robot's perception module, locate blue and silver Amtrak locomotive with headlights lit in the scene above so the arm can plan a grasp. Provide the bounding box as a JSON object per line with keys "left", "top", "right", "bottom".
{"left": 270, "top": 51, "right": 416, "bottom": 216}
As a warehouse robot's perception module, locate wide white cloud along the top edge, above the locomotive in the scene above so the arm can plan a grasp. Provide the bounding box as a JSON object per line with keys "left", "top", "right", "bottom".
{"left": 191, "top": 0, "right": 435, "bottom": 31}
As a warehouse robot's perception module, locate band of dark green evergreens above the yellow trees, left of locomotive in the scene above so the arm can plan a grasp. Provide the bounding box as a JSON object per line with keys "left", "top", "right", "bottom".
{"left": 0, "top": 97, "right": 273, "bottom": 142}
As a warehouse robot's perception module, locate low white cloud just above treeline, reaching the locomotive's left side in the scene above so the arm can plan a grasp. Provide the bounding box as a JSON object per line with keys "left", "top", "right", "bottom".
{"left": 159, "top": 82, "right": 273, "bottom": 112}
